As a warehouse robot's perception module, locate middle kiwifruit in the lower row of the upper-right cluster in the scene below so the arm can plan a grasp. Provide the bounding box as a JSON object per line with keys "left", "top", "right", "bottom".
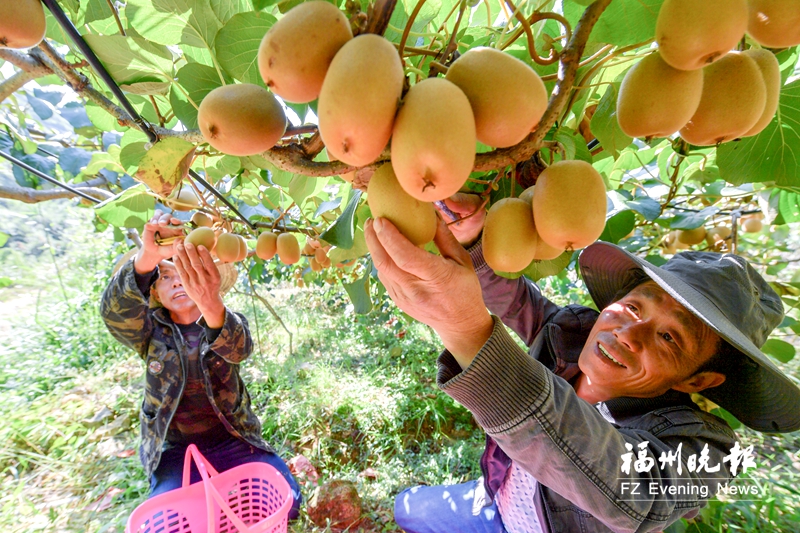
{"left": 681, "top": 52, "right": 767, "bottom": 146}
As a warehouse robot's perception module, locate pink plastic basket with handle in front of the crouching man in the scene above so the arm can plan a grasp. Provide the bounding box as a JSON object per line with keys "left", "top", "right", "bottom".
{"left": 125, "top": 444, "right": 292, "bottom": 533}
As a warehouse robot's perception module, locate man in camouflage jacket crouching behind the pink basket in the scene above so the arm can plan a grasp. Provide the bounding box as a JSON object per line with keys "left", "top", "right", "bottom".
{"left": 101, "top": 211, "right": 301, "bottom": 518}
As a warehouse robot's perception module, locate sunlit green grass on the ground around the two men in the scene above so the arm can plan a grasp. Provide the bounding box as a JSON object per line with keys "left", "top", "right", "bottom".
{"left": 0, "top": 204, "right": 800, "bottom": 533}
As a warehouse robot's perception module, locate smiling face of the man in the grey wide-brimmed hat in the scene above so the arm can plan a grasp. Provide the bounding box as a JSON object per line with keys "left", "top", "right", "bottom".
{"left": 578, "top": 281, "right": 720, "bottom": 398}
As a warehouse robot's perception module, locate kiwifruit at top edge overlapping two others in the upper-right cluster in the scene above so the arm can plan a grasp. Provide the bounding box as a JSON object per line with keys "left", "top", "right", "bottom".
{"left": 656, "top": 0, "right": 748, "bottom": 70}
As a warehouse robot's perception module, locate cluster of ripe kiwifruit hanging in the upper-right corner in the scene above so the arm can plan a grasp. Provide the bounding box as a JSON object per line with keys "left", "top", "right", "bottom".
{"left": 617, "top": 0, "right": 800, "bottom": 146}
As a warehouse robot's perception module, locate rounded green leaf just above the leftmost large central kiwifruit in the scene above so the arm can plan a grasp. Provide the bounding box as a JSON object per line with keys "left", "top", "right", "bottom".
{"left": 215, "top": 12, "right": 276, "bottom": 85}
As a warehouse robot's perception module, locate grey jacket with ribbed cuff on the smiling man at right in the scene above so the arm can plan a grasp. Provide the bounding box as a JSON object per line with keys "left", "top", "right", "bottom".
{"left": 437, "top": 246, "right": 736, "bottom": 533}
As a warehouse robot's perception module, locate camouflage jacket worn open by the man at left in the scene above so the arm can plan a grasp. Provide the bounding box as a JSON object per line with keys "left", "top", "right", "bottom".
{"left": 100, "top": 260, "right": 274, "bottom": 477}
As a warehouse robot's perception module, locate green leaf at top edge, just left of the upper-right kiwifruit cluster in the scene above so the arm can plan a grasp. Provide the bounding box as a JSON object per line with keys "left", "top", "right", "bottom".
{"left": 564, "top": 0, "right": 664, "bottom": 46}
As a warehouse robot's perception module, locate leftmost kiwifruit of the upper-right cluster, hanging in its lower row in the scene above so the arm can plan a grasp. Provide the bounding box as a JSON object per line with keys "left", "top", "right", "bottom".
{"left": 617, "top": 51, "right": 703, "bottom": 138}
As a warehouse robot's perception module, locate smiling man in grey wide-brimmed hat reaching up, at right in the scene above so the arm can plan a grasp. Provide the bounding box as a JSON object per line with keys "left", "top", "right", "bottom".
{"left": 365, "top": 194, "right": 800, "bottom": 533}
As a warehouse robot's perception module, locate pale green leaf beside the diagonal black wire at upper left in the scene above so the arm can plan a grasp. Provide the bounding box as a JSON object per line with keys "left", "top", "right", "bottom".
{"left": 83, "top": 34, "right": 173, "bottom": 88}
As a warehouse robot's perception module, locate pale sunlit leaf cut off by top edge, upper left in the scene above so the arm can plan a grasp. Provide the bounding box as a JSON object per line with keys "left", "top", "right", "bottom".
{"left": 125, "top": 0, "right": 222, "bottom": 50}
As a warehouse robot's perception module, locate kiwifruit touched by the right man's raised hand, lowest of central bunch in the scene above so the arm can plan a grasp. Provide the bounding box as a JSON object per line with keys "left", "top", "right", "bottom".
{"left": 367, "top": 163, "right": 437, "bottom": 245}
